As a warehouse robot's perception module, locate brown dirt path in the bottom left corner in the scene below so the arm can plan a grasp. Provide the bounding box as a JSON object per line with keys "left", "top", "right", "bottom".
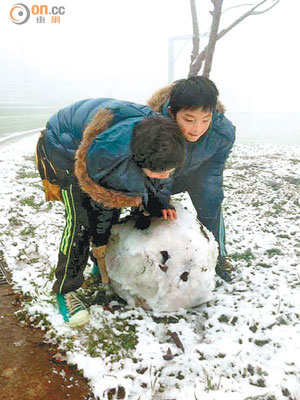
{"left": 0, "top": 285, "right": 94, "bottom": 400}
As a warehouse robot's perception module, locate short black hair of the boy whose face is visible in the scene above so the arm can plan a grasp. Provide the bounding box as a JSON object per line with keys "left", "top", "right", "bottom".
{"left": 169, "top": 76, "right": 219, "bottom": 115}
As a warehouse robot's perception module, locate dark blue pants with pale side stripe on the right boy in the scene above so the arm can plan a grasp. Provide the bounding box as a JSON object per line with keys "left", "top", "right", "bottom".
{"left": 172, "top": 171, "right": 227, "bottom": 256}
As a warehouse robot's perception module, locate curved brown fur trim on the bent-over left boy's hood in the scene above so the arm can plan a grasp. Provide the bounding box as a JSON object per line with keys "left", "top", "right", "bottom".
{"left": 75, "top": 108, "right": 142, "bottom": 208}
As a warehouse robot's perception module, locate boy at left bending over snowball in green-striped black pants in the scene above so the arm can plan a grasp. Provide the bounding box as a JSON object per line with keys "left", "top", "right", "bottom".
{"left": 37, "top": 99, "right": 185, "bottom": 327}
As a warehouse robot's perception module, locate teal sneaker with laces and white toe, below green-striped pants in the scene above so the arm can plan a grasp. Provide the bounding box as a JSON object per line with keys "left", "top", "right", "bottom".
{"left": 56, "top": 292, "right": 90, "bottom": 328}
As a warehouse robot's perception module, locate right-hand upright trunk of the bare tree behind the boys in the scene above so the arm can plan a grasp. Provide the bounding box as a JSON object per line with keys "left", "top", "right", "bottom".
{"left": 203, "top": 0, "right": 223, "bottom": 78}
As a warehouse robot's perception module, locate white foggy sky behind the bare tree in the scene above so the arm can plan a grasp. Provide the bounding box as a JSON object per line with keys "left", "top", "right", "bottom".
{"left": 0, "top": 0, "right": 300, "bottom": 112}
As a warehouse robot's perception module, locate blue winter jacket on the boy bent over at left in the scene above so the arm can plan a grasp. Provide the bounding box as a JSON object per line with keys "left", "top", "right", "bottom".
{"left": 45, "top": 98, "right": 172, "bottom": 208}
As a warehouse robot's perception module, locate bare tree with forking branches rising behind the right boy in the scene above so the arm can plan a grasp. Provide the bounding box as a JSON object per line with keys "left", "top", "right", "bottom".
{"left": 189, "top": 0, "right": 280, "bottom": 78}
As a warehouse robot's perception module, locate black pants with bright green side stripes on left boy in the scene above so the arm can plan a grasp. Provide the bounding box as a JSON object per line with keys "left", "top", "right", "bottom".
{"left": 53, "top": 181, "right": 120, "bottom": 293}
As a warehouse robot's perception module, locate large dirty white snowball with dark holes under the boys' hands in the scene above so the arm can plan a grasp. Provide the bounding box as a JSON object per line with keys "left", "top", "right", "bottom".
{"left": 106, "top": 204, "right": 218, "bottom": 311}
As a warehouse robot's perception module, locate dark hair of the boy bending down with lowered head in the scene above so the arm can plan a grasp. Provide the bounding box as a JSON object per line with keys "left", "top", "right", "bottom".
{"left": 131, "top": 116, "right": 185, "bottom": 172}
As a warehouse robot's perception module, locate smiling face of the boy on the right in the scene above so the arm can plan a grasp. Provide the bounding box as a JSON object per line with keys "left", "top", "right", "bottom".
{"left": 176, "top": 108, "right": 212, "bottom": 142}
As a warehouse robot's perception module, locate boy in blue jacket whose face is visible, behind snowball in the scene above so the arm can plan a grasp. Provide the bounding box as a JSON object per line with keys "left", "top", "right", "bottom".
{"left": 147, "top": 76, "right": 235, "bottom": 281}
